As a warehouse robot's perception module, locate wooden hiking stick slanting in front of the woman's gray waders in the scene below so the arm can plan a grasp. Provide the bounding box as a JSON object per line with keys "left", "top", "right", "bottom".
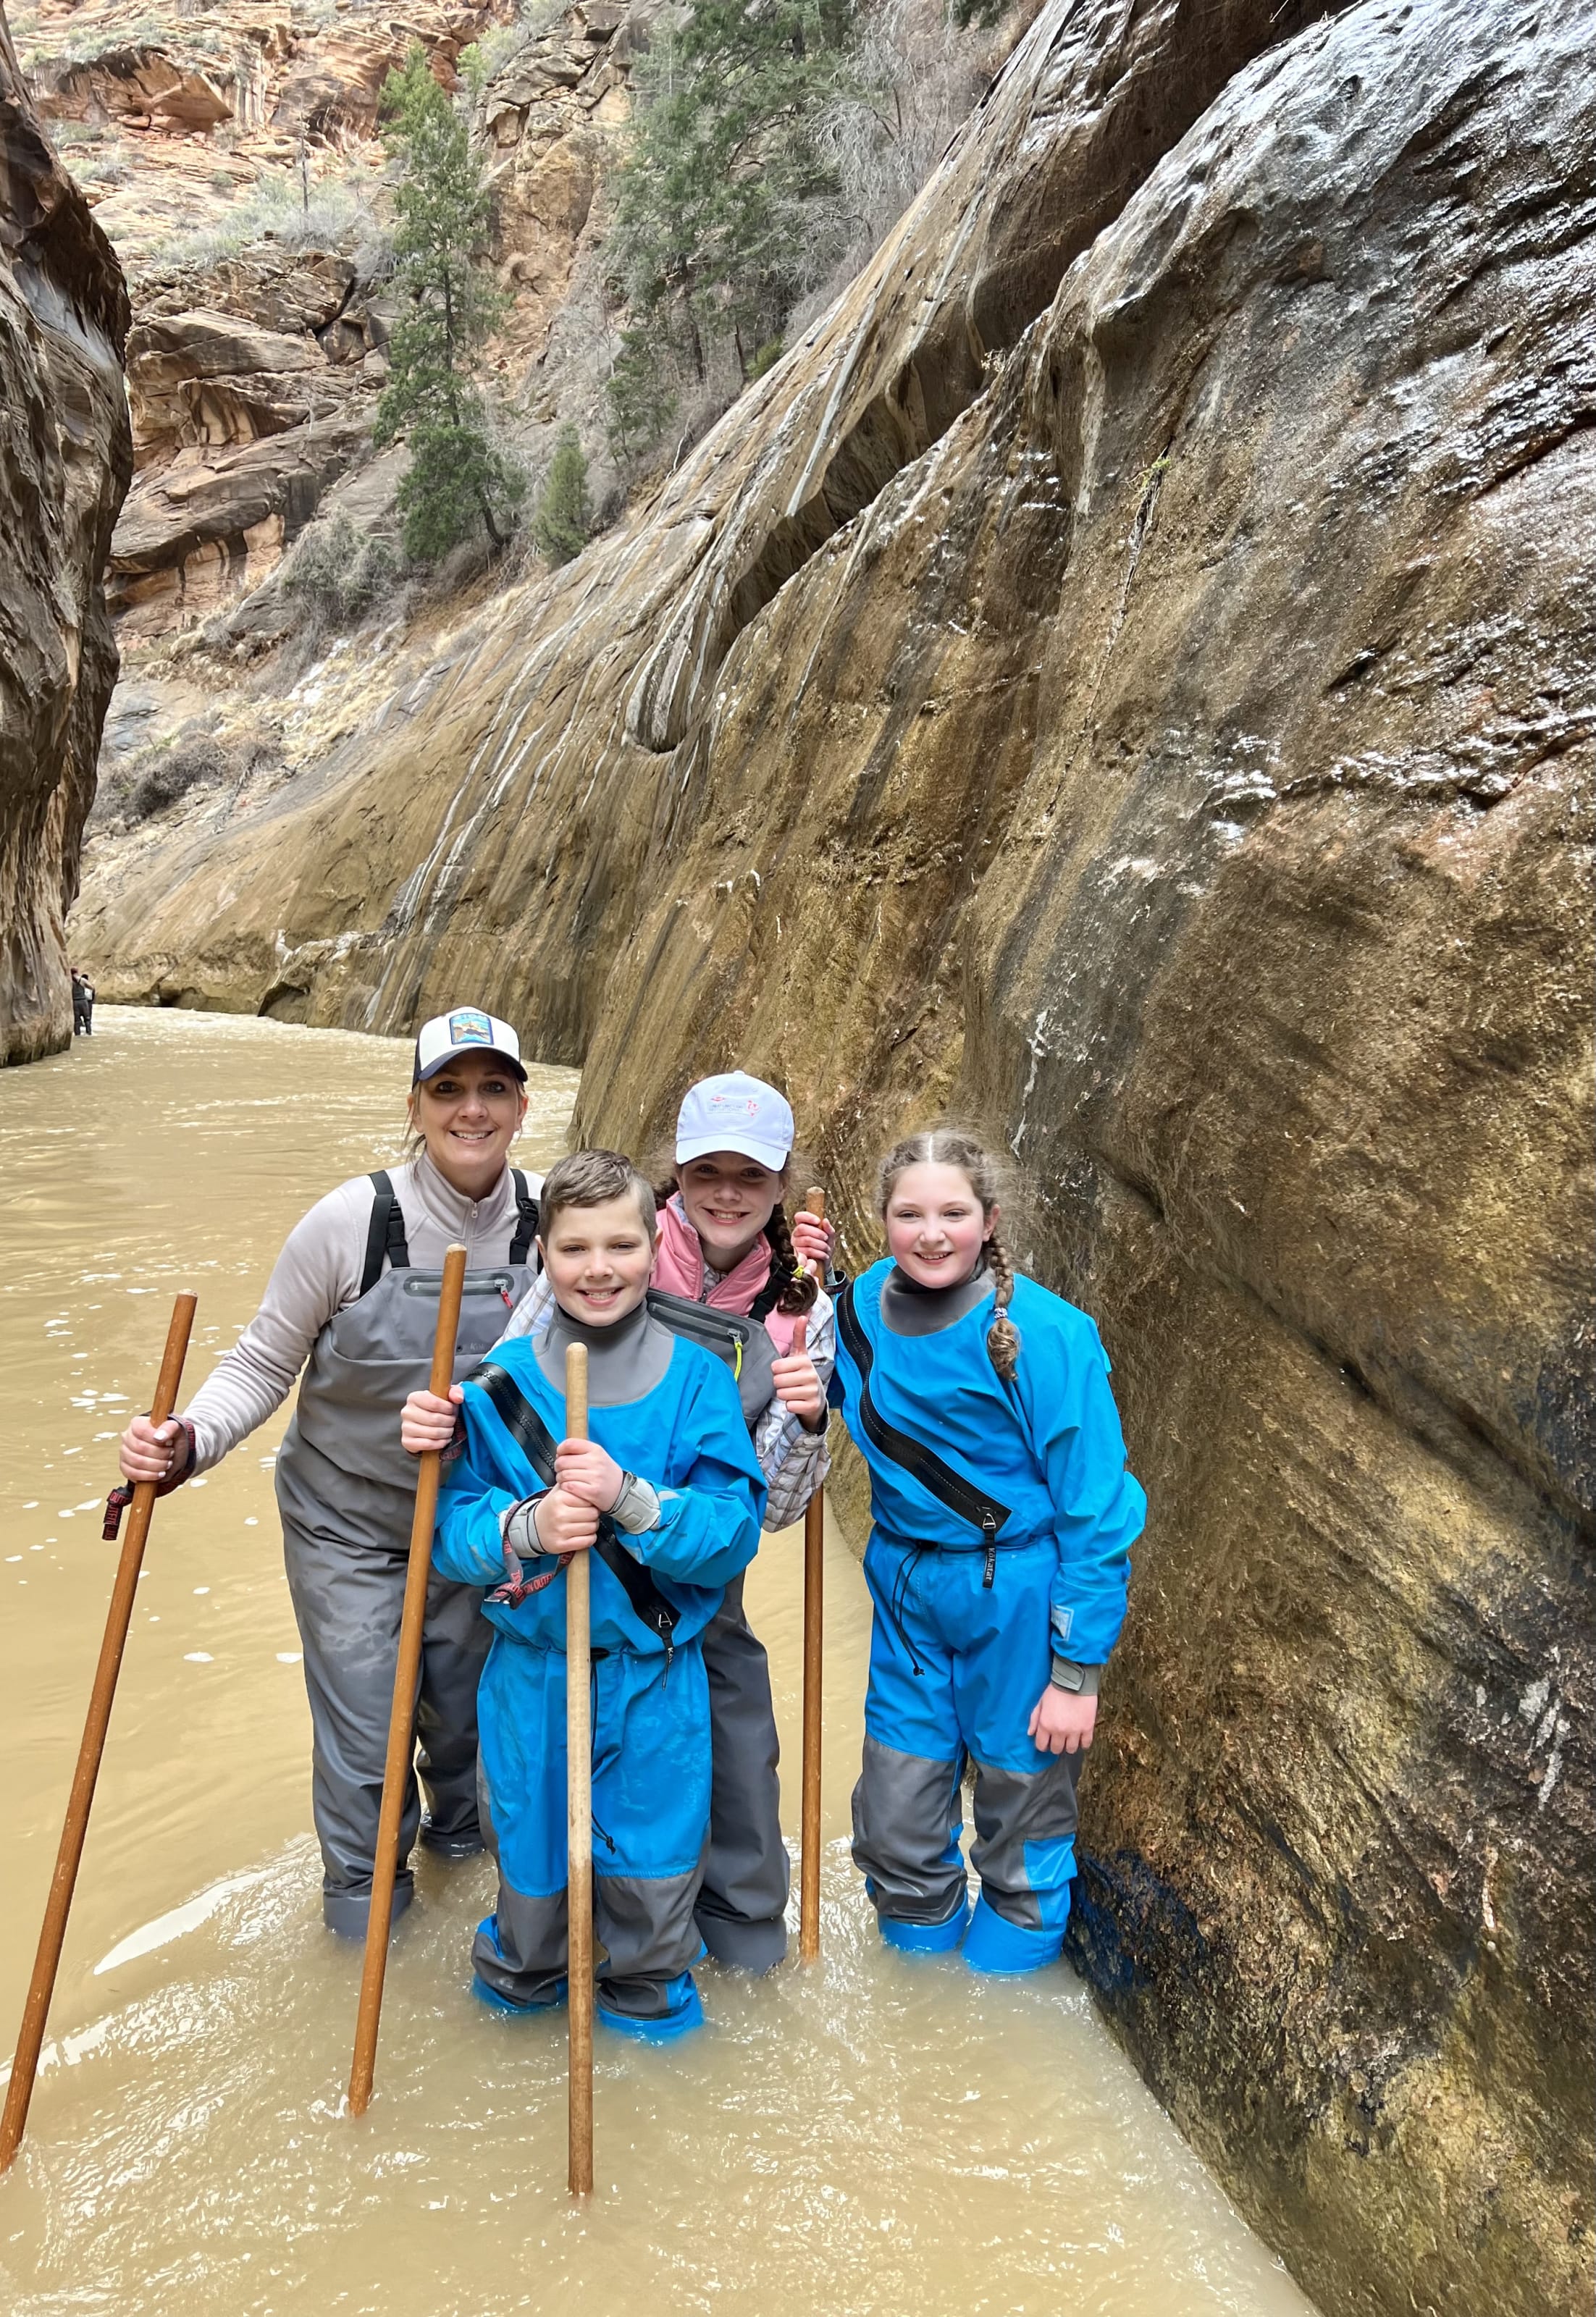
{"left": 350, "top": 1244, "right": 466, "bottom": 2116}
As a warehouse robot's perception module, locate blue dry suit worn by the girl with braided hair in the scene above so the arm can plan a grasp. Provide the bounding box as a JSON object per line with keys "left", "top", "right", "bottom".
{"left": 831, "top": 1263, "right": 1146, "bottom": 1972}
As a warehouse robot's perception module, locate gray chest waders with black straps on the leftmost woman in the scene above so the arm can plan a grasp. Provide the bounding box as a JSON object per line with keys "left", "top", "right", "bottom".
{"left": 276, "top": 1174, "right": 537, "bottom": 1937}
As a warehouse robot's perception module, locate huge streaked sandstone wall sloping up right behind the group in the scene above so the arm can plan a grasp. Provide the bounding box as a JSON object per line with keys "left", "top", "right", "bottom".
{"left": 68, "top": 0, "right": 1596, "bottom": 2317}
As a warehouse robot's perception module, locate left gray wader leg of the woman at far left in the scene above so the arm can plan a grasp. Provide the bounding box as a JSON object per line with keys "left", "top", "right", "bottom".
{"left": 282, "top": 1520, "right": 421, "bottom": 1937}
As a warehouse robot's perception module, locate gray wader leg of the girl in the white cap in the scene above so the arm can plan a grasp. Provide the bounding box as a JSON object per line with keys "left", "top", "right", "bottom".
{"left": 697, "top": 1578, "right": 790, "bottom": 1972}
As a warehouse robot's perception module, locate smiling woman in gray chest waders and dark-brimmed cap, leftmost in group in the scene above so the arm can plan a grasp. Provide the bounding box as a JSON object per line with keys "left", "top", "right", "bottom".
{"left": 120, "top": 1006, "right": 537, "bottom": 1937}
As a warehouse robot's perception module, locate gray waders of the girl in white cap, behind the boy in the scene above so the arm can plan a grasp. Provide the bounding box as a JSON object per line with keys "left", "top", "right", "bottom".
{"left": 649, "top": 1290, "right": 790, "bottom": 1972}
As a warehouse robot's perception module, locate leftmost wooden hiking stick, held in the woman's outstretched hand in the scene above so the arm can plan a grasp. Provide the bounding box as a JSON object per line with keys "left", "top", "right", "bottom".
{"left": 0, "top": 1295, "right": 195, "bottom": 2171}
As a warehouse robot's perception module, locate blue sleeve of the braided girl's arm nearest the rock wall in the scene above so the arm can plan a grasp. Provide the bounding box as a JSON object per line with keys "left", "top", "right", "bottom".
{"left": 1017, "top": 1313, "right": 1146, "bottom": 1666}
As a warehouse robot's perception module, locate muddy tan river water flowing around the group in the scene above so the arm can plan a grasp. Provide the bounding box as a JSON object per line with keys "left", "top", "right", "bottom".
{"left": 0, "top": 1008, "right": 1309, "bottom": 2317}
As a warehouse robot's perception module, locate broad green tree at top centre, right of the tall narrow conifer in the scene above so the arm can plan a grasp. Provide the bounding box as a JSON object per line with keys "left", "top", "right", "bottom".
{"left": 607, "top": 0, "right": 852, "bottom": 396}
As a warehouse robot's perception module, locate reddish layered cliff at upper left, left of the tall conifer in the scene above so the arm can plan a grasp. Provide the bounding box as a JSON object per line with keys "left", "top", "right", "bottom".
{"left": 21, "top": 0, "right": 508, "bottom": 644}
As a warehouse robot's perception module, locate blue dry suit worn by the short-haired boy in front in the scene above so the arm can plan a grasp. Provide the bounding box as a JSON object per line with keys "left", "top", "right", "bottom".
{"left": 433, "top": 1337, "right": 765, "bottom": 2027}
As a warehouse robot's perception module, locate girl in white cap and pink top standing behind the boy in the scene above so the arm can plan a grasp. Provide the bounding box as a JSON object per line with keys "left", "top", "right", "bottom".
{"left": 403, "top": 1070, "right": 836, "bottom": 1972}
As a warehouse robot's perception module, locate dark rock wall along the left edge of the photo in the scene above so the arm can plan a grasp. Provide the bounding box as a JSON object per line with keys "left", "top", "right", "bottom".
{"left": 0, "top": 0, "right": 132, "bottom": 1061}
